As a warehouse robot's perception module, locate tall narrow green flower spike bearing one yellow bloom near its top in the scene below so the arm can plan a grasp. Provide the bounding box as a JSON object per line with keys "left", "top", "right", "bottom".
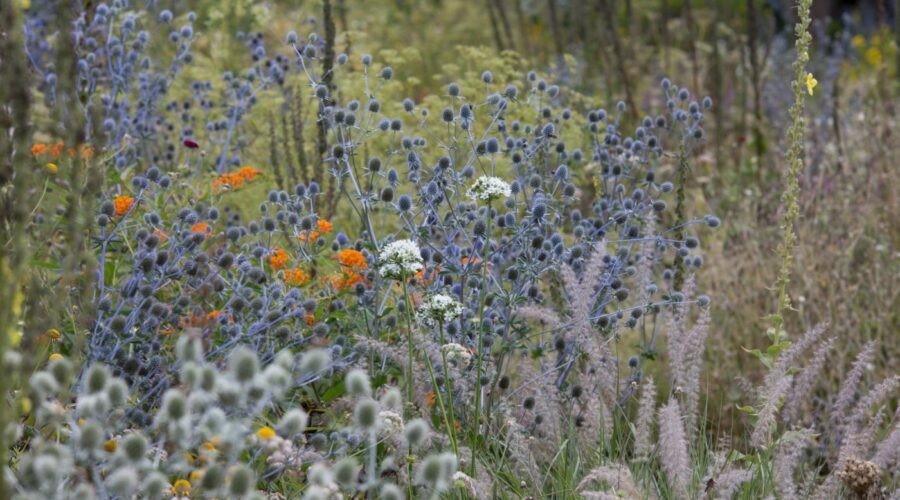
{"left": 771, "top": 0, "right": 812, "bottom": 336}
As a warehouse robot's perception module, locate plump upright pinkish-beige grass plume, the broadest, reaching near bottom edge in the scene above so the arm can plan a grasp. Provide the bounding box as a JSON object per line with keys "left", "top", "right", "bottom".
{"left": 659, "top": 398, "right": 691, "bottom": 498}
